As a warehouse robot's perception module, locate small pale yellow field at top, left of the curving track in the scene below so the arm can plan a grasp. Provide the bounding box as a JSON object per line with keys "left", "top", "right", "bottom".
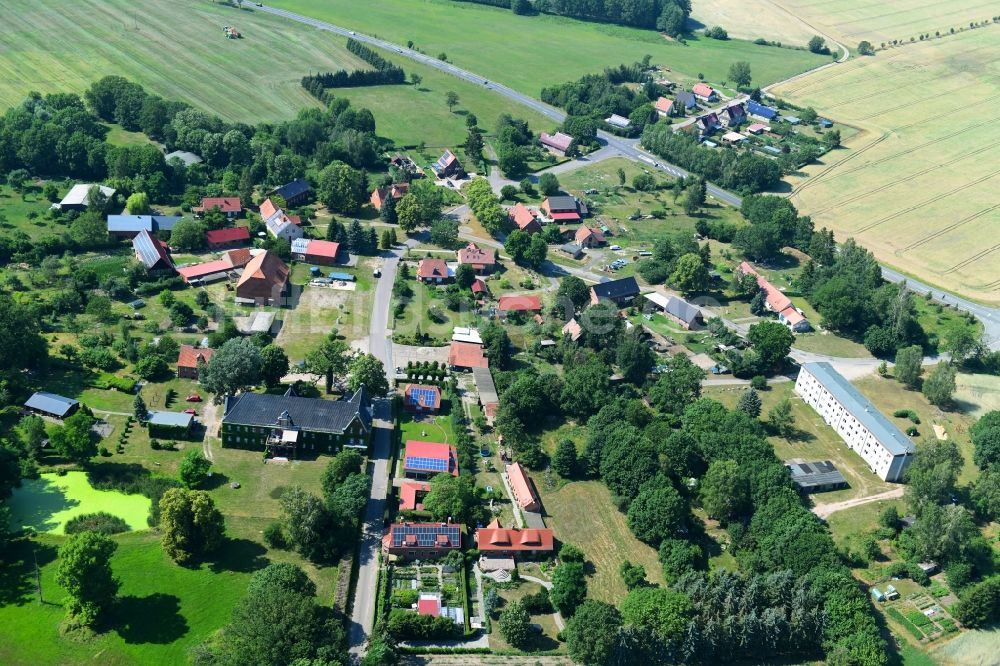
{"left": 691, "top": 0, "right": 816, "bottom": 46}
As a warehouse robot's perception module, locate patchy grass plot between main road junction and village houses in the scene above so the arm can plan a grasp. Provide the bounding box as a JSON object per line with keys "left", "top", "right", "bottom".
{"left": 559, "top": 157, "right": 743, "bottom": 248}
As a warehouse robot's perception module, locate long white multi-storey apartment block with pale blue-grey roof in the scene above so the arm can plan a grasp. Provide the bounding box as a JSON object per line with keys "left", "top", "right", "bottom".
{"left": 795, "top": 363, "right": 915, "bottom": 482}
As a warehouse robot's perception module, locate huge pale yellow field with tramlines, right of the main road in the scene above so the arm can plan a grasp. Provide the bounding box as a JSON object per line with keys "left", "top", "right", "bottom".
{"left": 772, "top": 25, "right": 1000, "bottom": 303}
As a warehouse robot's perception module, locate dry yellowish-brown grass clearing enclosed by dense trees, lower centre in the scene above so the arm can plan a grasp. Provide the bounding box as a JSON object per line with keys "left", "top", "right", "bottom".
{"left": 535, "top": 481, "right": 663, "bottom": 604}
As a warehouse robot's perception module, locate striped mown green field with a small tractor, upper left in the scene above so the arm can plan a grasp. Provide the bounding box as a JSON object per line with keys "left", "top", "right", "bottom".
{"left": 0, "top": 0, "right": 366, "bottom": 121}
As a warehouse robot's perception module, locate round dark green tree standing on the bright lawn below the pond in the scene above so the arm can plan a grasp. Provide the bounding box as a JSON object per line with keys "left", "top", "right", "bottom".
{"left": 56, "top": 531, "right": 120, "bottom": 626}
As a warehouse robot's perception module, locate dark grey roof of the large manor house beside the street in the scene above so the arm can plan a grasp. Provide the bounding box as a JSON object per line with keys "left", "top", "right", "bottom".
{"left": 222, "top": 386, "right": 372, "bottom": 434}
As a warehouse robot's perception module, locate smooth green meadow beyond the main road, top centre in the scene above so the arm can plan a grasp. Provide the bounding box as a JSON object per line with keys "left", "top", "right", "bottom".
{"left": 270, "top": 0, "right": 829, "bottom": 97}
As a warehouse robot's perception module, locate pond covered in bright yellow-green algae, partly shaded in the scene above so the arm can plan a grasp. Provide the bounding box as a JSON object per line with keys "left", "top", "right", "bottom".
{"left": 10, "top": 472, "right": 151, "bottom": 534}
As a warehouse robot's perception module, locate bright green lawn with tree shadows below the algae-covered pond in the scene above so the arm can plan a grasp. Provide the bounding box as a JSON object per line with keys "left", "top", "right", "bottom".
{"left": 0, "top": 532, "right": 252, "bottom": 666}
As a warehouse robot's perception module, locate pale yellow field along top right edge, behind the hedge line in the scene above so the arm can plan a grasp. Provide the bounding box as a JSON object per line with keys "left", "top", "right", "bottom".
{"left": 760, "top": 0, "right": 1000, "bottom": 49}
